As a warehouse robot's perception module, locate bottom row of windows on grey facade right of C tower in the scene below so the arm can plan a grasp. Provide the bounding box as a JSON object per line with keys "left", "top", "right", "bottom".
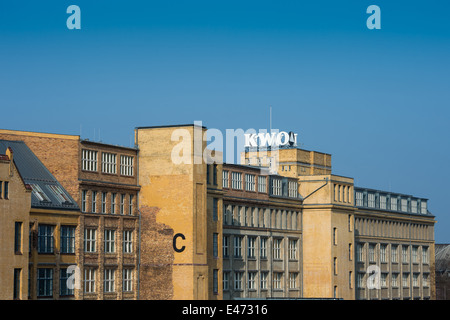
{"left": 223, "top": 271, "right": 299, "bottom": 291}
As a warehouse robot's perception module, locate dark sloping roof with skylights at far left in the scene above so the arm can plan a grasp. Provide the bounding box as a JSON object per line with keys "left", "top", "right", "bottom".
{"left": 0, "top": 140, "right": 79, "bottom": 210}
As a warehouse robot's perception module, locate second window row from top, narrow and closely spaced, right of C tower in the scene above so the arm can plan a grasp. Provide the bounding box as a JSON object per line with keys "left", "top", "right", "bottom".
{"left": 223, "top": 205, "right": 300, "bottom": 230}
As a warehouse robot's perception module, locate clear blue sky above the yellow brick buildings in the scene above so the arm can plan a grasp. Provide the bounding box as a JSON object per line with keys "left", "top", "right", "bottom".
{"left": 0, "top": 0, "right": 450, "bottom": 243}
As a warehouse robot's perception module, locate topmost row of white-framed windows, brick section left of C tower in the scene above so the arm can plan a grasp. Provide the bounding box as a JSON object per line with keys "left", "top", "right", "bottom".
{"left": 81, "top": 149, "right": 134, "bottom": 176}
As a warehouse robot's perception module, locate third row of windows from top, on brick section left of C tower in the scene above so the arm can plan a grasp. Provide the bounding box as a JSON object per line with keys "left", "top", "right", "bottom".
{"left": 84, "top": 228, "right": 133, "bottom": 253}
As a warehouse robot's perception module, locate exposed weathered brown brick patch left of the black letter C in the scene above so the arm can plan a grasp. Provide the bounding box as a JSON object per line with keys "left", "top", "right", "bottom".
{"left": 140, "top": 207, "right": 174, "bottom": 300}
